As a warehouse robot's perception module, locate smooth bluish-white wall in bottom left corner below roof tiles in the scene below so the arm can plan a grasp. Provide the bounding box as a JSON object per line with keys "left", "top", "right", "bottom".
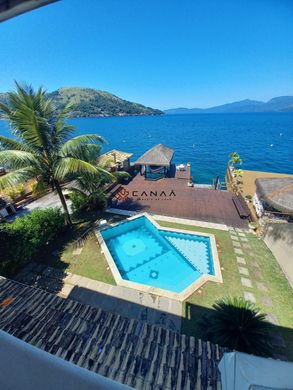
{"left": 0, "top": 331, "right": 130, "bottom": 390}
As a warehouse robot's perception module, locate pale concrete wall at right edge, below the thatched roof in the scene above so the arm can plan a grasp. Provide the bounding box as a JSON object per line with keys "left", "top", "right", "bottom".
{"left": 264, "top": 223, "right": 293, "bottom": 288}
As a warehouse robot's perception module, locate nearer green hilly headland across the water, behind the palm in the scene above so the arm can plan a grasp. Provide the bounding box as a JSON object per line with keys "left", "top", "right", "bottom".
{"left": 0, "top": 87, "right": 164, "bottom": 117}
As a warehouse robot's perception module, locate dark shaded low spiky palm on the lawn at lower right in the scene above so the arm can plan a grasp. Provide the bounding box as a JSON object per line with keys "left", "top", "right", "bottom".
{"left": 199, "top": 297, "right": 271, "bottom": 356}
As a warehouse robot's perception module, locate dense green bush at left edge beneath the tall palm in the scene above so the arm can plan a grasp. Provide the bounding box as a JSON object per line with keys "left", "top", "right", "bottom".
{"left": 0, "top": 208, "right": 65, "bottom": 276}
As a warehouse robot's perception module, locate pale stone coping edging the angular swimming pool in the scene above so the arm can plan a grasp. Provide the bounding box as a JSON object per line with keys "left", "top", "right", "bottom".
{"left": 95, "top": 212, "right": 223, "bottom": 302}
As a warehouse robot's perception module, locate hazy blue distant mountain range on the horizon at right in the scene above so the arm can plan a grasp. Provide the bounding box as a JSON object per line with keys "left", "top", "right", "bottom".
{"left": 164, "top": 96, "right": 293, "bottom": 115}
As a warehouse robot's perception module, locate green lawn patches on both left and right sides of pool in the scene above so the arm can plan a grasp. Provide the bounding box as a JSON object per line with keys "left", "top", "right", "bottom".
{"left": 33, "top": 213, "right": 293, "bottom": 360}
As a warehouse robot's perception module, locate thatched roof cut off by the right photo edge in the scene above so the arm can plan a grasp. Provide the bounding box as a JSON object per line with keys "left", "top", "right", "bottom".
{"left": 255, "top": 177, "right": 293, "bottom": 215}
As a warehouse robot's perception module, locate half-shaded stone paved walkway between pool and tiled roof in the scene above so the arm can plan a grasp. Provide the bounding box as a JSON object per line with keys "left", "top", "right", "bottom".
{"left": 15, "top": 263, "right": 182, "bottom": 331}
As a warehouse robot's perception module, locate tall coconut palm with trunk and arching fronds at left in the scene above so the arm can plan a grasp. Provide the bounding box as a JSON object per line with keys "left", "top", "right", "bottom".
{"left": 0, "top": 83, "right": 104, "bottom": 223}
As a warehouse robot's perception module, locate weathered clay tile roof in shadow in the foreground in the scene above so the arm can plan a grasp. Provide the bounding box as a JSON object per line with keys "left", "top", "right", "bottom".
{"left": 0, "top": 277, "right": 226, "bottom": 390}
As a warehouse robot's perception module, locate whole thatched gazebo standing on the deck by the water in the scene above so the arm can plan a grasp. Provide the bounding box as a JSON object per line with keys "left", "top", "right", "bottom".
{"left": 134, "top": 144, "right": 174, "bottom": 180}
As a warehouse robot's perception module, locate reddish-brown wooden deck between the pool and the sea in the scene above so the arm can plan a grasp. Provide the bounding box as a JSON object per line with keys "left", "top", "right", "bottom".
{"left": 111, "top": 175, "right": 248, "bottom": 228}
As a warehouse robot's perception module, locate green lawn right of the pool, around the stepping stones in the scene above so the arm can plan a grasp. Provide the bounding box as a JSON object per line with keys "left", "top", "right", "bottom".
{"left": 158, "top": 221, "right": 293, "bottom": 360}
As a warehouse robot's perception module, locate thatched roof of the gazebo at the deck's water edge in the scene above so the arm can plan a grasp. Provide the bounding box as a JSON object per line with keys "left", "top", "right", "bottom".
{"left": 135, "top": 144, "right": 174, "bottom": 166}
